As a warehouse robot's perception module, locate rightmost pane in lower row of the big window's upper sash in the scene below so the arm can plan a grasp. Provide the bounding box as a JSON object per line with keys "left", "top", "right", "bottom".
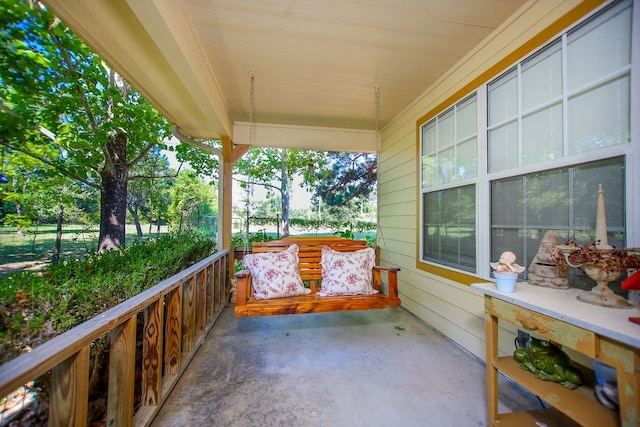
{"left": 568, "top": 75, "right": 631, "bottom": 154}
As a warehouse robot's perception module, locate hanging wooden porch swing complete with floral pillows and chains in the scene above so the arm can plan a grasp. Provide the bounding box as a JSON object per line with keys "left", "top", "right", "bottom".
{"left": 235, "top": 77, "right": 400, "bottom": 317}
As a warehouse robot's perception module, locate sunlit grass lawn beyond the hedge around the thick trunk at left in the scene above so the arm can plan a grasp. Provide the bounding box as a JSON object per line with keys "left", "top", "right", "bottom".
{"left": 0, "top": 224, "right": 167, "bottom": 276}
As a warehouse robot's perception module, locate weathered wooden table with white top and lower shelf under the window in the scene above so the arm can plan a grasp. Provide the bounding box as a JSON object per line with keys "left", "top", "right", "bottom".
{"left": 471, "top": 282, "right": 640, "bottom": 427}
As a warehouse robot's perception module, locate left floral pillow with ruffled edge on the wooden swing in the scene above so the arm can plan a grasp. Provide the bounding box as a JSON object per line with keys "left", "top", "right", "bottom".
{"left": 243, "top": 244, "right": 311, "bottom": 299}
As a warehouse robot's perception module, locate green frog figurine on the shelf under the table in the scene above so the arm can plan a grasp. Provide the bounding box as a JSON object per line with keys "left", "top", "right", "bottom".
{"left": 513, "top": 336, "right": 582, "bottom": 390}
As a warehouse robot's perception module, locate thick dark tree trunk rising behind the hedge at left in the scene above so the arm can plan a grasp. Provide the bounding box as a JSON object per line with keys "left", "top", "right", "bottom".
{"left": 98, "top": 132, "right": 129, "bottom": 252}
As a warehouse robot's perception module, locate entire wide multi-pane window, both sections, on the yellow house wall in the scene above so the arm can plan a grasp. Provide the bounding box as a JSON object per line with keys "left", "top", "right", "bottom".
{"left": 419, "top": 0, "right": 639, "bottom": 277}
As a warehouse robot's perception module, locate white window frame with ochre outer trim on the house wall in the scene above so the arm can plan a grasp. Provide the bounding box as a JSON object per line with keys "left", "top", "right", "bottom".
{"left": 416, "top": 1, "right": 640, "bottom": 284}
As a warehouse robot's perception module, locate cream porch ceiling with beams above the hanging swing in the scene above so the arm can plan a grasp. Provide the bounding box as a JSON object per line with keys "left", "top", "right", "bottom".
{"left": 45, "top": 0, "right": 525, "bottom": 151}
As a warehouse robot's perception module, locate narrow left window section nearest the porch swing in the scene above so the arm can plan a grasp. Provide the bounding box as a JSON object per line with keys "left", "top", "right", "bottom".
{"left": 421, "top": 94, "right": 478, "bottom": 272}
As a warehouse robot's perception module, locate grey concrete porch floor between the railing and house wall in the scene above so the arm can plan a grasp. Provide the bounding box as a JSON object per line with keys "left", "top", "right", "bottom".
{"left": 152, "top": 307, "right": 540, "bottom": 427}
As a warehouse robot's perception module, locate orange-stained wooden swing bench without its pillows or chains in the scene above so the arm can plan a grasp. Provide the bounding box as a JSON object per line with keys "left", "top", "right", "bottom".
{"left": 235, "top": 237, "right": 400, "bottom": 317}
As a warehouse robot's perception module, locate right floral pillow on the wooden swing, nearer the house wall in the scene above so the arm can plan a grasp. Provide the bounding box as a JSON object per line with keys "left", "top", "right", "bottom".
{"left": 318, "top": 246, "right": 378, "bottom": 296}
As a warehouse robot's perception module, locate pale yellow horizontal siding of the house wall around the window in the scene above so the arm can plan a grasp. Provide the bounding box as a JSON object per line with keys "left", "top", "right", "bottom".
{"left": 378, "top": 0, "right": 603, "bottom": 359}
